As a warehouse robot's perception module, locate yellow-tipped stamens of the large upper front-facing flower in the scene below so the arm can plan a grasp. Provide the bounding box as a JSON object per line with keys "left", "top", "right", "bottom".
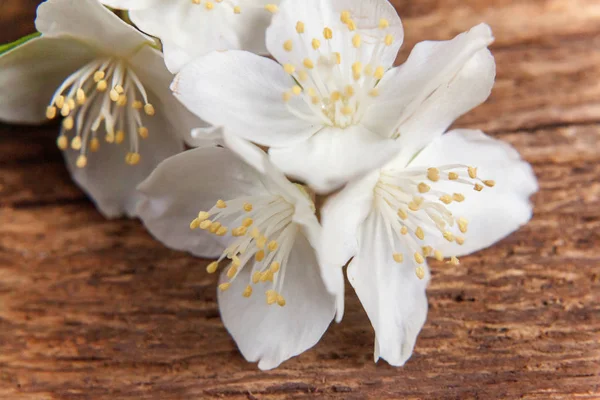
{"left": 283, "top": 11, "right": 394, "bottom": 128}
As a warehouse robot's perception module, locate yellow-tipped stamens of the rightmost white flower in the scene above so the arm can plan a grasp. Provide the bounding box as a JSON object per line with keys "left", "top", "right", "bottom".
{"left": 375, "top": 165, "right": 495, "bottom": 279}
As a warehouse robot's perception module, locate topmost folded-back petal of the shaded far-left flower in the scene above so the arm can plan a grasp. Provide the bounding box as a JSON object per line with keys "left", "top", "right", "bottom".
{"left": 35, "top": 0, "right": 152, "bottom": 57}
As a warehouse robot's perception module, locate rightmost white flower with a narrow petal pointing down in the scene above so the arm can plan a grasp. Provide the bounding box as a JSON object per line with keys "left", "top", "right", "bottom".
{"left": 321, "top": 130, "right": 537, "bottom": 366}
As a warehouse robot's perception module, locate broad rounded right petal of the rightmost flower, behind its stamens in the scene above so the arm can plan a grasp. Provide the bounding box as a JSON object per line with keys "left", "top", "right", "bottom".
{"left": 410, "top": 130, "right": 538, "bottom": 256}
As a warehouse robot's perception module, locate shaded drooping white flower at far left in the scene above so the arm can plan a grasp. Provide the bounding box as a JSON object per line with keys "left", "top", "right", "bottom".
{"left": 0, "top": 0, "right": 202, "bottom": 217}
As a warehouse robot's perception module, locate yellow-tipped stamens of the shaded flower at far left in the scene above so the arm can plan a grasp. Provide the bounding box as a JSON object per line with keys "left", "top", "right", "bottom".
{"left": 46, "top": 58, "right": 155, "bottom": 168}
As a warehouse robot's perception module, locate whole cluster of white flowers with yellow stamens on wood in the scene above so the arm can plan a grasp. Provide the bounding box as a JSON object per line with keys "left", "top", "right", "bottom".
{"left": 0, "top": 0, "right": 537, "bottom": 369}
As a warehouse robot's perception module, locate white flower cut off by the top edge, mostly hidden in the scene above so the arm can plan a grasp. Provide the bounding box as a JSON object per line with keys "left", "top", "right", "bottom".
{"left": 101, "top": 0, "right": 279, "bottom": 72}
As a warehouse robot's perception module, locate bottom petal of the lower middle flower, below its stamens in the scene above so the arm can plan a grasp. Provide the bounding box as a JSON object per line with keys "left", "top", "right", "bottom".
{"left": 219, "top": 235, "right": 335, "bottom": 370}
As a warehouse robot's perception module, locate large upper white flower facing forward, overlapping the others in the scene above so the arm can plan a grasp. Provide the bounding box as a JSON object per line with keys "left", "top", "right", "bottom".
{"left": 172, "top": 0, "right": 493, "bottom": 193}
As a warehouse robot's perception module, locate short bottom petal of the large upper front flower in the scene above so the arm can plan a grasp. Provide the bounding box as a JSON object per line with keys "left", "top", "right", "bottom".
{"left": 269, "top": 126, "right": 399, "bottom": 193}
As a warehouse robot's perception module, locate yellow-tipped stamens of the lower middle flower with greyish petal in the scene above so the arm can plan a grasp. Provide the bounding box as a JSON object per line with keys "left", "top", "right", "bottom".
{"left": 190, "top": 195, "right": 298, "bottom": 307}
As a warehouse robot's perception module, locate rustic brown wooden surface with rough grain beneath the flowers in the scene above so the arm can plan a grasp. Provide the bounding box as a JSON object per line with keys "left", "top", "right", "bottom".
{"left": 0, "top": 0, "right": 600, "bottom": 400}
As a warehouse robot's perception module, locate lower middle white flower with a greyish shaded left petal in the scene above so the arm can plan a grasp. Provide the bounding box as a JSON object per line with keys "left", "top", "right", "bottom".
{"left": 138, "top": 136, "right": 341, "bottom": 369}
